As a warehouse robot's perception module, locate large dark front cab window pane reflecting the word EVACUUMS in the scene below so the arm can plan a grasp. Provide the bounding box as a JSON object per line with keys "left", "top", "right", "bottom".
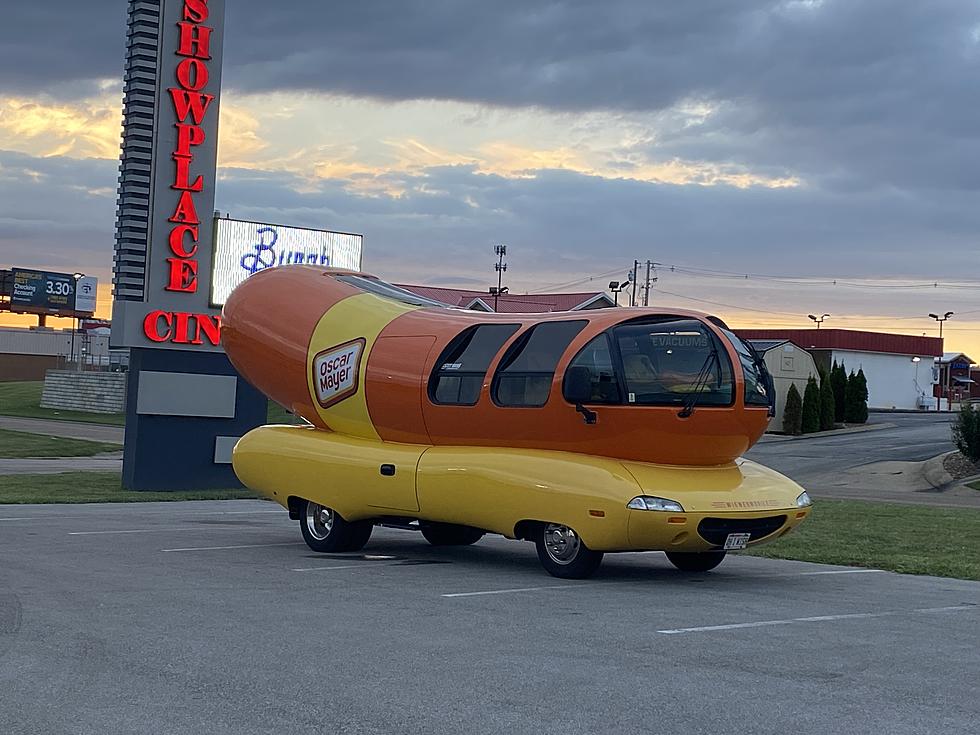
{"left": 613, "top": 319, "right": 734, "bottom": 406}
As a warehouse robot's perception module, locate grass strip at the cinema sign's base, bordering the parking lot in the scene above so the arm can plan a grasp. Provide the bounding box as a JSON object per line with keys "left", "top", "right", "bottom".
{"left": 0, "top": 472, "right": 257, "bottom": 503}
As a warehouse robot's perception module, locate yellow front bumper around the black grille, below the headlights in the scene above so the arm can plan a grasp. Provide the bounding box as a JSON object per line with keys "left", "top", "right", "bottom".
{"left": 627, "top": 507, "right": 811, "bottom": 551}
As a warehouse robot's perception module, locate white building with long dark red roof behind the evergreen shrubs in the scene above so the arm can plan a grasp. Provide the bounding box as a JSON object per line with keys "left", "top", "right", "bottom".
{"left": 735, "top": 329, "right": 940, "bottom": 410}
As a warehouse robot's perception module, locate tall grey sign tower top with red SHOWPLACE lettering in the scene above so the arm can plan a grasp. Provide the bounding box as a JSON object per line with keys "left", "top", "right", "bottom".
{"left": 112, "top": 0, "right": 224, "bottom": 350}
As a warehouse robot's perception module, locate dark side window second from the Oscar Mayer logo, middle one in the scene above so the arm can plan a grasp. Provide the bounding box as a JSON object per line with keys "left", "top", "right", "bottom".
{"left": 493, "top": 320, "right": 588, "bottom": 407}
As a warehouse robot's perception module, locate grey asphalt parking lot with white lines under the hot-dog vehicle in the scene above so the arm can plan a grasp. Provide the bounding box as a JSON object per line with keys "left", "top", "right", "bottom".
{"left": 0, "top": 501, "right": 980, "bottom": 735}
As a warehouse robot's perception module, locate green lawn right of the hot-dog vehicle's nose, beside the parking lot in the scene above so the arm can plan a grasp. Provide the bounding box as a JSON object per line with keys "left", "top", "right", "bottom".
{"left": 743, "top": 500, "right": 980, "bottom": 580}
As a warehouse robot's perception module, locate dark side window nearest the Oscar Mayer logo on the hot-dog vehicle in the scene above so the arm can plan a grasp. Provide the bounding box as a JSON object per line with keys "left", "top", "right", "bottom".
{"left": 429, "top": 324, "right": 520, "bottom": 406}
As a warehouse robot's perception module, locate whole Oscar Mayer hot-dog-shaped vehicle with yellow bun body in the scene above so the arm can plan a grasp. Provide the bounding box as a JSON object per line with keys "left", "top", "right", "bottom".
{"left": 222, "top": 265, "right": 810, "bottom": 578}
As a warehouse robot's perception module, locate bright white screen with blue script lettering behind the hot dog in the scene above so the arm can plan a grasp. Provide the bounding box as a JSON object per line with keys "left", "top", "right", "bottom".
{"left": 211, "top": 219, "right": 364, "bottom": 307}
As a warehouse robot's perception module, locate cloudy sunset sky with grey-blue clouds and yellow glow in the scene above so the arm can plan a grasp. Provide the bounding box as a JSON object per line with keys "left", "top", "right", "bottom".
{"left": 0, "top": 0, "right": 980, "bottom": 359}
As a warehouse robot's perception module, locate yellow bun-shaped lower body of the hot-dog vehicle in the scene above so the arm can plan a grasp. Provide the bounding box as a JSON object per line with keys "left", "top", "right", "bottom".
{"left": 234, "top": 426, "right": 810, "bottom": 552}
